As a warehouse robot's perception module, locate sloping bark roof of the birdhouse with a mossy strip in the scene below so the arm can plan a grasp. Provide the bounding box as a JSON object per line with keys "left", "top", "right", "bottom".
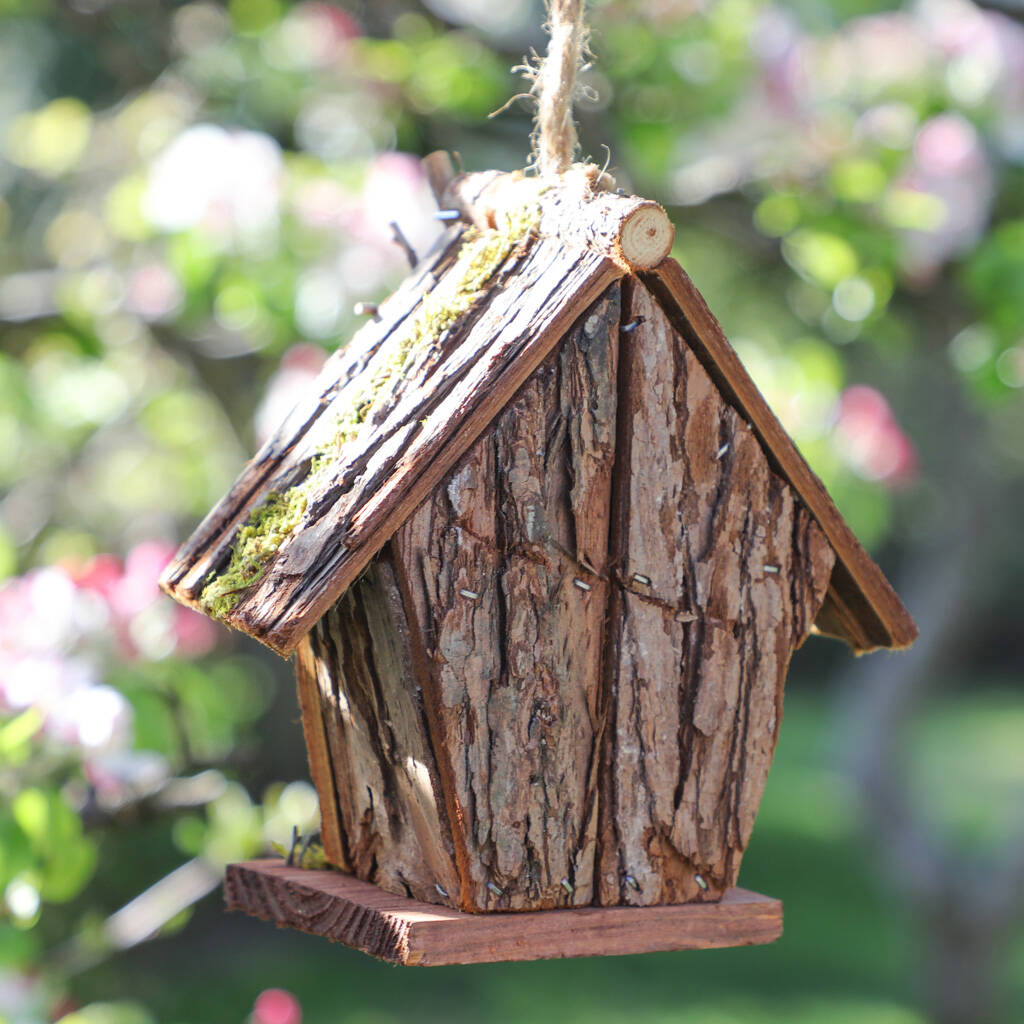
{"left": 161, "top": 167, "right": 916, "bottom": 655}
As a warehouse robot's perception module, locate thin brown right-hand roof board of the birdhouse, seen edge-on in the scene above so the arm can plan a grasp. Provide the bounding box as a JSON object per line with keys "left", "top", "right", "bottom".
{"left": 640, "top": 257, "right": 918, "bottom": 653}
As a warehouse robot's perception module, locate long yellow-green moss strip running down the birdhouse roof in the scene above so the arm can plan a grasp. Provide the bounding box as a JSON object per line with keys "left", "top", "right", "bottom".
{"left": 200, "top": 198, "right": 540, "bottom": 618}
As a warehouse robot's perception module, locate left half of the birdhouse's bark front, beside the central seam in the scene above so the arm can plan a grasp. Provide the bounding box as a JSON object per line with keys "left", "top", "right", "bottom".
{"left": 389, "top": 285, "right": 620, "bottom": 910}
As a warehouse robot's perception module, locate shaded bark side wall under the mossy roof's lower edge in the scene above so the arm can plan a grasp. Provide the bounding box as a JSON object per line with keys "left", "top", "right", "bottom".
{"left": 298, "top": 558, "right": 458, "bottom": 902}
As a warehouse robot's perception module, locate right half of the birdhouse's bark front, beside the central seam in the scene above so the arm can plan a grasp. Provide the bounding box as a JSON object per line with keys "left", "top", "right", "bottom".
{"left": 599, "top": 283, "right": 834, "bottom": 905}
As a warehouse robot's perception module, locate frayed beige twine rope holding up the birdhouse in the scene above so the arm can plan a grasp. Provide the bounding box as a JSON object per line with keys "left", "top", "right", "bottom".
{"left": 530, "top": 0, "right": 588, "bottom": 177}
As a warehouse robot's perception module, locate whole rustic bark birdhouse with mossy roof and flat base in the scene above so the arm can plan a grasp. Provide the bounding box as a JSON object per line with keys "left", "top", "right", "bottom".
{"left": 162, "top": 155, "right": 916, "bottom": 963}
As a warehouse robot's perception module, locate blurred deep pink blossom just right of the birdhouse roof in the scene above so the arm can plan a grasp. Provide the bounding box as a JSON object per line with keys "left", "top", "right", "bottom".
{"left": 835, "top": 385, "right": 918, "bottom": 487}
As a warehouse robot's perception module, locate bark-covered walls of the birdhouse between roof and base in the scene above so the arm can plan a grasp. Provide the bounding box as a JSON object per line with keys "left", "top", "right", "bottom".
{"left": 299, "top": 279, "right": 834, "bottom": 910}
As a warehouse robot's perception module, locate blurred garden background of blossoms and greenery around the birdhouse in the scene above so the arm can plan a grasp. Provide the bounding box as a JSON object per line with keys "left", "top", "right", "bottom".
{"left": 0, "top": 0, "right": 1024, "bottom": 1024}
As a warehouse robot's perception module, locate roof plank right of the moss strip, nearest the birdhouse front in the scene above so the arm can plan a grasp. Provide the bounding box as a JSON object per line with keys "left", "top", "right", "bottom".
{"left": 227, "top": 239, "right": 623, "bottom": 655}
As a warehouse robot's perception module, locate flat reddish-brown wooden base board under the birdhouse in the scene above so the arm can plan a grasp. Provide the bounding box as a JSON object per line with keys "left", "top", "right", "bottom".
{"left": 224, "top": 860, "right": 782, "bottom": 967}
